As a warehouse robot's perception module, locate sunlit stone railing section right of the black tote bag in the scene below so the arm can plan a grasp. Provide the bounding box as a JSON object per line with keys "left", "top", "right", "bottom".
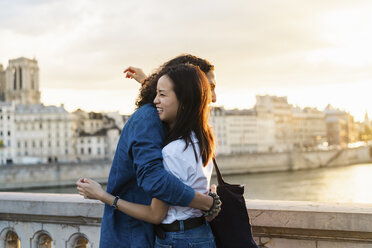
{"left": 246, "top": 200, "right": 372, "bottom": 247}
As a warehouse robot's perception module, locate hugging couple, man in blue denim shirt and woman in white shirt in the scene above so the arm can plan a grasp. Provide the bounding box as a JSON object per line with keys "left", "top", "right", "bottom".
{"left": 76, "top": 55, "right": 221, "bottom": 248}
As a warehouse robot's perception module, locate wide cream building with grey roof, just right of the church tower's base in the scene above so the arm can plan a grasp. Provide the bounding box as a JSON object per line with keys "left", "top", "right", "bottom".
{"left": 14, "top": 104, "right": 75, "bottom": 164}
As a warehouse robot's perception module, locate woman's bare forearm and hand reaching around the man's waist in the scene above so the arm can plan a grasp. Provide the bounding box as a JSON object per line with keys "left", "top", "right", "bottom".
{"left": 76, "top": 178, "right": 168, "bottom": 224}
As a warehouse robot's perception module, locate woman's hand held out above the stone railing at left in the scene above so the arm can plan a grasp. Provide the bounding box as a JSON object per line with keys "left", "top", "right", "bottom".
{"left": 76, "top": 178, "right": 106, "bottom": 200}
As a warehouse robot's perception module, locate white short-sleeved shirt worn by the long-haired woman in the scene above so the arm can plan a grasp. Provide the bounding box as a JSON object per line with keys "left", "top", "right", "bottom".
{"left": 162, "top": 132, "right": 213, "bottom": 224}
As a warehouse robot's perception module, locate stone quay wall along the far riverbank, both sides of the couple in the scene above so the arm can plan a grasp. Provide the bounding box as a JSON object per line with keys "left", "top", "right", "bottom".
{"left": 0, "top": 147, "right": 372, "bottom": 191}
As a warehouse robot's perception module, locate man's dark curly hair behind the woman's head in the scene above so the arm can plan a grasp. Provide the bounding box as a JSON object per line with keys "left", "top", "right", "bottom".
{"left": 135, "top": 54, "right": 214, "bottom": 109}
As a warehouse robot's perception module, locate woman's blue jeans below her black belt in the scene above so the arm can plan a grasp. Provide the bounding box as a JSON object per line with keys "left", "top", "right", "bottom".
{"left": 155, "top": 221, "right": 216, "bottom": 248}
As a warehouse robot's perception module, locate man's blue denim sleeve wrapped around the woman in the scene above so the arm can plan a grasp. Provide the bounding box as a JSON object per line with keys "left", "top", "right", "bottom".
{"left": 129, "top": 107, "right": 195, "bottom": 206}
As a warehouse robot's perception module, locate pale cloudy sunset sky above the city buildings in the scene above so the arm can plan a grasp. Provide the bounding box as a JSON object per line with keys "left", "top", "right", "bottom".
{"left": 0, "top": 0, "right": 372, "bottom": 120}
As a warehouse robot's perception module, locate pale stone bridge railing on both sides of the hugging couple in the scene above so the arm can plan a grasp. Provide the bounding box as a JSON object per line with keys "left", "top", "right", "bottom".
{"left": 0, "top": 193, "right": 372, "bottom": 248}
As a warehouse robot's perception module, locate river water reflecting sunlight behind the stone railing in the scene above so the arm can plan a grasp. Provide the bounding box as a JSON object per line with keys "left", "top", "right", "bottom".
{"left": 16, "top": 164, "right": 372, "bottom": 203}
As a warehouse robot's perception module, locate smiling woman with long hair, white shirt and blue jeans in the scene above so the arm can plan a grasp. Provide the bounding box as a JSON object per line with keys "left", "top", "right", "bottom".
{"left": 78, "top": 65, "right": 218, "bottom": 247}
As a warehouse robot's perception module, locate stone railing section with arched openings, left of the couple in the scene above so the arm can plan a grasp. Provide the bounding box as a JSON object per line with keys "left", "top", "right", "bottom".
{"left": 0, "top": 193, "right": 103, "bottom": 248}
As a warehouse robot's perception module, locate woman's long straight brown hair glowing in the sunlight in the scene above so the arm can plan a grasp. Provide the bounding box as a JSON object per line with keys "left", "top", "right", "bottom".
{"left": 159, "top": 64, "right": 214, "bottom": 166}
